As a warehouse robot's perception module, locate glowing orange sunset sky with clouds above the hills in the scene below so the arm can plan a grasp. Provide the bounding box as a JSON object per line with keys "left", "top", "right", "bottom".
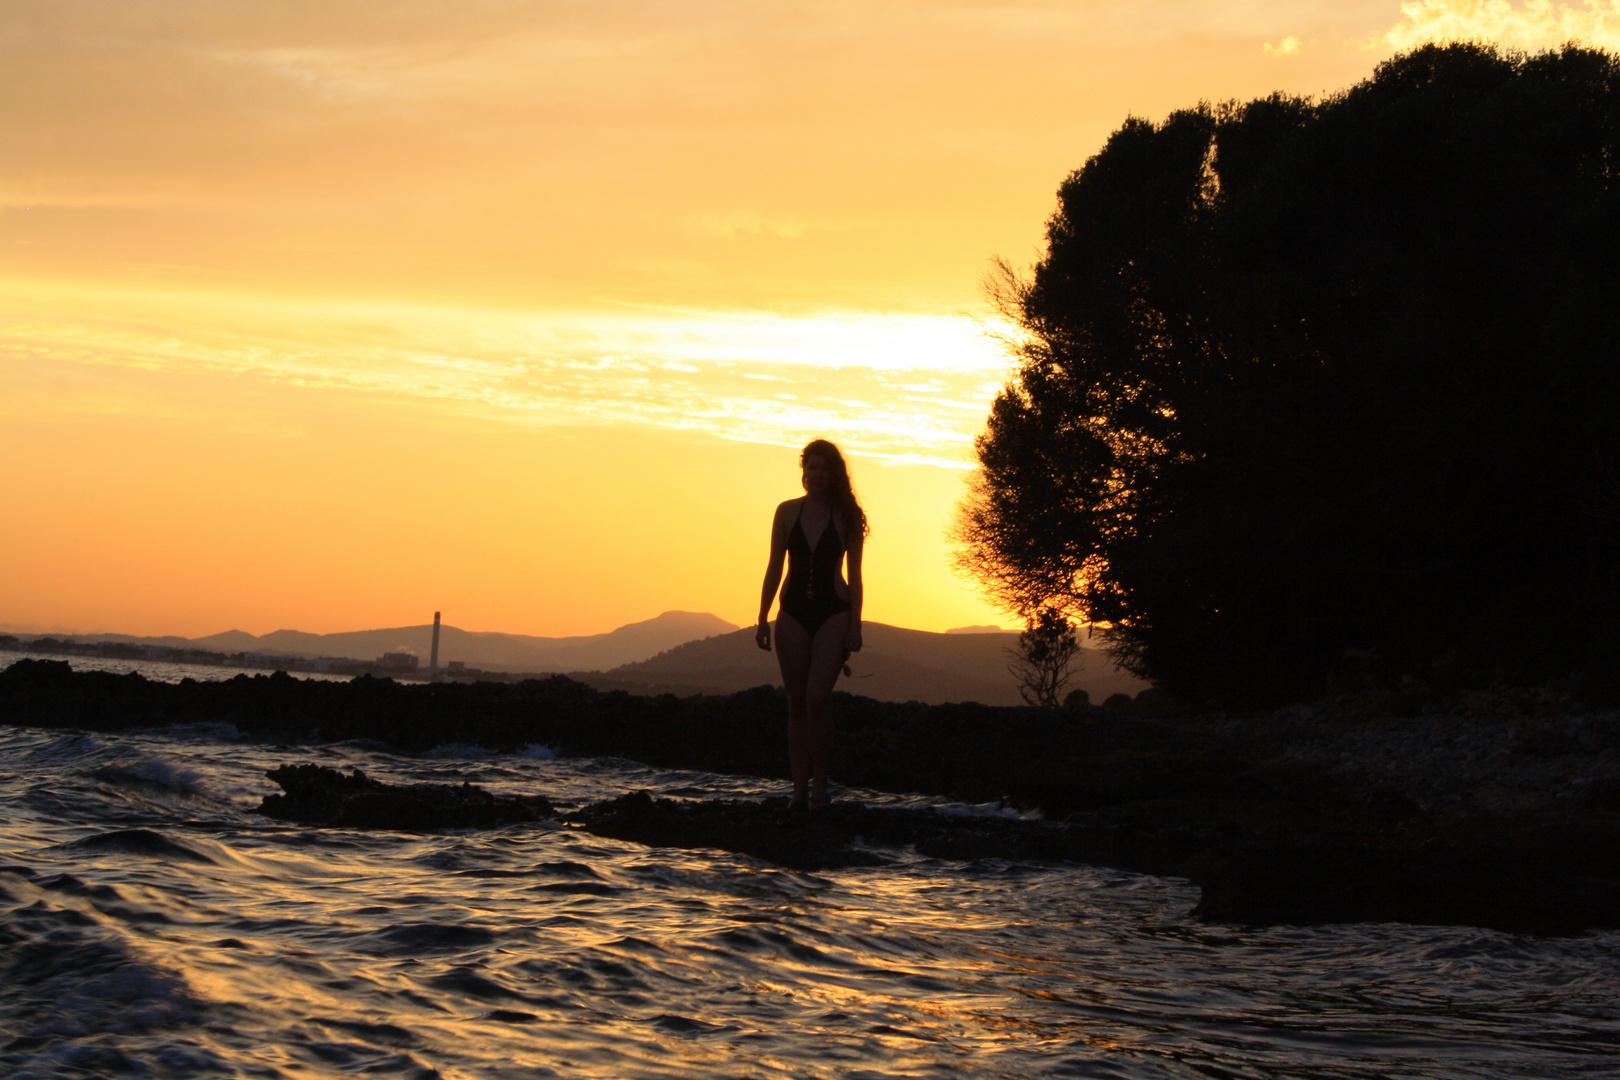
{"left": 9, "top": 0, "right": 1620, "bottom": 636}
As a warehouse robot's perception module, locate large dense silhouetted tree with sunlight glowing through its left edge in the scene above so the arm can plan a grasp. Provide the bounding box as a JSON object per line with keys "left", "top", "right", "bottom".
{"left": 956, "top": 45, "right": 1620, "bottom": 701}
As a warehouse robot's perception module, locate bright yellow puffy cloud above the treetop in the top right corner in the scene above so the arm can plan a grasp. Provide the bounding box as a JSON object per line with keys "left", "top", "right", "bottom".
{"left": 1382, "top": 0, "right": 1620, "bottom": 52}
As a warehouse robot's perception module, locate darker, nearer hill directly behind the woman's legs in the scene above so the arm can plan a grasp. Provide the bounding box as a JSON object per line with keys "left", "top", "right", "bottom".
{"left": 591, "top": 622, "right": 1147, "bottom": 704}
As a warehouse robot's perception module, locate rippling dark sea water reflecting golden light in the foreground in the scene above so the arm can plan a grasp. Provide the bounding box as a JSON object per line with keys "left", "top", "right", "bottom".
{"left": 0, "top": 654, "right": 1620, "bottom": 1078}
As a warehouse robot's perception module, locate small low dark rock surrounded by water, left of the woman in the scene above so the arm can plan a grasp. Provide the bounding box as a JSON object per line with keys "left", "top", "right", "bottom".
{"left": 259, "top": 764, "right": 554, "bottom": 832}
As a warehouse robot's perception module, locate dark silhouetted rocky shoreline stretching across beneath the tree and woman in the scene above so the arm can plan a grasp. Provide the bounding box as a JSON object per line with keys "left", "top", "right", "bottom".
{"left": 0, "top": 661, "right": 1620, "bottom": 934}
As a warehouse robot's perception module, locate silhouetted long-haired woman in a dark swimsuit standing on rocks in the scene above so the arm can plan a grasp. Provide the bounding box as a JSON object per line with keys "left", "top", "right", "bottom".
{"left": 753, "top": 439, "right": 867, "bottom": 810}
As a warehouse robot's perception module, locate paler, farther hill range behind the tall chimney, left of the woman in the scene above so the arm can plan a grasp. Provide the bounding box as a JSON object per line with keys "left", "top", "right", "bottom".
{"left": 81, "top": 612, "right": 737, "bottom": 672}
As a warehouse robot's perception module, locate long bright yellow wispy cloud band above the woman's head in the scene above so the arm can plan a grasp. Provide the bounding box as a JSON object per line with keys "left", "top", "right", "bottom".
{"left": 0, "top": 284, "right": 1008, "bottom": 468}
